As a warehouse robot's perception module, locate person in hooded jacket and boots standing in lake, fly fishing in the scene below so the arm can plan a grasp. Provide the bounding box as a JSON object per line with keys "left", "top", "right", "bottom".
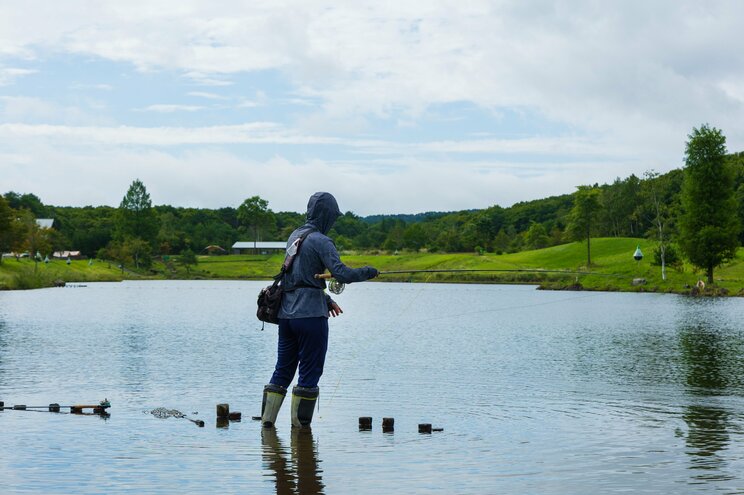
{"left": 261, "top": 192, "right": 378, "bottom": 427}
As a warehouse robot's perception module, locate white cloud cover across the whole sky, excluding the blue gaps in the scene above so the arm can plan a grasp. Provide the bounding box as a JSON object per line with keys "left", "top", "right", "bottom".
{"left": 0, "top": 0, "right": 744, "bottom": 212}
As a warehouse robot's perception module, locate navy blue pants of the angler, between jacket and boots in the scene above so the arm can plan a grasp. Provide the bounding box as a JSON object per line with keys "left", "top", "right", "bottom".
{"left": 271, "top": 316, "right": 328, "bottom": 388}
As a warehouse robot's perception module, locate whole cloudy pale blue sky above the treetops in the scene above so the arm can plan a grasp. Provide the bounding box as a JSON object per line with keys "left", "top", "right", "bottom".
{"left": 0, "top": 0, "right": 744, "bottom": 215}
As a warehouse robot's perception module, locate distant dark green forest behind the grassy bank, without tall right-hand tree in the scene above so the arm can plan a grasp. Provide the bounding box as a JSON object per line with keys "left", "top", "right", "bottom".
{"left": 4, "top": 153, "right": 744, "bottom": 257}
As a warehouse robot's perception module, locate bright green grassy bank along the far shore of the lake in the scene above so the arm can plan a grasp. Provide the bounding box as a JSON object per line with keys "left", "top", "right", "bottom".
{"left": 0, "top": 238, "right": 744, "bottom": 295}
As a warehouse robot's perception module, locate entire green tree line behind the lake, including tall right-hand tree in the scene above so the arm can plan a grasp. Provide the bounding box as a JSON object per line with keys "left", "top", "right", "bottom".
{"left": 0, "top": 125, "right": 744, "bottom": 276}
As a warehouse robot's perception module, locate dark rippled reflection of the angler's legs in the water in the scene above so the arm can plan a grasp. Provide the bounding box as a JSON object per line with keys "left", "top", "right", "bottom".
{"left": 261, "top": 428, "right": 325, "bottom": 495}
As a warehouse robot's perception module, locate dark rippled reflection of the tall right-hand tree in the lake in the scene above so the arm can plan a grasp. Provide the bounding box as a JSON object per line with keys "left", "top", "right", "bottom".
{"left": 679, "top": 316, "right": 739, "bottom": 483}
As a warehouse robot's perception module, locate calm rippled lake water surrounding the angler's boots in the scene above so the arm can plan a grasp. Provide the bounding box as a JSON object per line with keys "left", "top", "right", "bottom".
{"left": 0, "top": 282, "right": 744, "bottom": 494}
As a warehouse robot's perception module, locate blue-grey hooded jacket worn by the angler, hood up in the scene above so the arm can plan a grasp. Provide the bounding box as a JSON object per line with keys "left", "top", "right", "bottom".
{"left": 279, "top": 192, "right": 377, "bottom": 319}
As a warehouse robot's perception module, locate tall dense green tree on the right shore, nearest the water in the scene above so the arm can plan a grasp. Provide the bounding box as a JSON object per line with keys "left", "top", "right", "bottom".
{"left": 679, "top": 124, "right": 739, "bottom": 283}
